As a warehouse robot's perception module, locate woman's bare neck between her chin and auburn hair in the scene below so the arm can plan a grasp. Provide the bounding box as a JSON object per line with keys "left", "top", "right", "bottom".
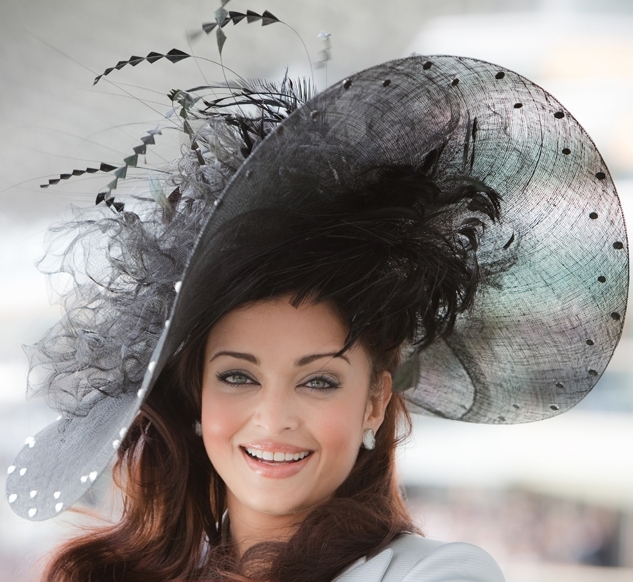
{"left": 227, "top": 494, "right": 307, "bottom": 557}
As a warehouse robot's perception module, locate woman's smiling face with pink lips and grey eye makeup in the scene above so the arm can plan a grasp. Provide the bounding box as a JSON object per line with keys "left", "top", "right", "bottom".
{"left": 202, "top": 298, "right": 391, "bottom": 517}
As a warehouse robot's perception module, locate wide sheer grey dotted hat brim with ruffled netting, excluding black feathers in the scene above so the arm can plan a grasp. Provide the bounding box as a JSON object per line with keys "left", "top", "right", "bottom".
{"left": 7, "top": 56, "right": 628, "bottom": 520}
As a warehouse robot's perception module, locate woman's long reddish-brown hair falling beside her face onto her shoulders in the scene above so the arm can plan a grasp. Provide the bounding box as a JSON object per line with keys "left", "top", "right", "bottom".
{"left": 44, "top": 346, "right": 417, "bottom": 582}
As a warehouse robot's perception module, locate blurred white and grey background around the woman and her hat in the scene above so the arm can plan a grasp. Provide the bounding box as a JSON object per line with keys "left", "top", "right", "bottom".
{"left": 0, "top": 0, "right": 633, "bottom": 582}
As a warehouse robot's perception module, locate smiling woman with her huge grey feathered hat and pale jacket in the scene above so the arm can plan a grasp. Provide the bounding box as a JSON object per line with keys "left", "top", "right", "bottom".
{"left": 7, "top": 28, "right": 627, "bottom": 582}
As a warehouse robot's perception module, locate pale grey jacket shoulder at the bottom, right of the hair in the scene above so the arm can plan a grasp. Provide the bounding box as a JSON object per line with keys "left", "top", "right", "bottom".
{"left": 336, "top": 535, "right": 505, "bottom": 582}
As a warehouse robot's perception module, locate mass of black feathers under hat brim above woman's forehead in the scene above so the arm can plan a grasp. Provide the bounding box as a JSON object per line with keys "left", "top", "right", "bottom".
{"left": 178, "top": 160, "right": 499, "bottom": 356}
